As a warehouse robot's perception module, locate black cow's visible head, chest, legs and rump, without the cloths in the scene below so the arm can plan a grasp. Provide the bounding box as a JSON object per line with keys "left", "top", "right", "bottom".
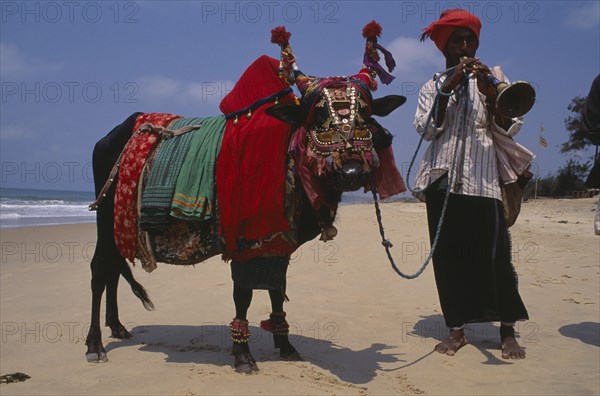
{"left": 86, "top": 42, "right": 405, "bottom": 373}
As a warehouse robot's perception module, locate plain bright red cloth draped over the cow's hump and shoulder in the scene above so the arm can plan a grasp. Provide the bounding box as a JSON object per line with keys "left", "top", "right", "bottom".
{"left": 216, "top": 55, "right": 295, "bottom": 261}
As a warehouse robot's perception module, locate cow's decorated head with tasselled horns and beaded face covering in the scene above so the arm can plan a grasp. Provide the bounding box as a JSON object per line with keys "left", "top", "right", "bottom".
{"left": 267, "top": 22, "right": 406, "bottom": 192}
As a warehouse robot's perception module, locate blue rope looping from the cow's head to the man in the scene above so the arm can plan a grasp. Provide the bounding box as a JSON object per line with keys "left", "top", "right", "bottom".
{"left": 370, "top": 66, "right": 469, "bottom": 279}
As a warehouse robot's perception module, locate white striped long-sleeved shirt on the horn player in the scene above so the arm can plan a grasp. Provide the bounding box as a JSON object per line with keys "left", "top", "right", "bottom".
{"left": 413, "top": 68, "right": 523, "bottom": 201}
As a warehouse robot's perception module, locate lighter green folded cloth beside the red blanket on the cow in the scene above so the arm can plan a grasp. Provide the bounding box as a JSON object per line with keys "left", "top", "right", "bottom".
{"left": 171, "top": 116, "right": 225, "bottom": 221}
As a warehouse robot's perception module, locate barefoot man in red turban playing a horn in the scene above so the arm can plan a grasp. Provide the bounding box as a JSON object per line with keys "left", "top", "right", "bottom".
{"left": 413, "top": 9, "right": 533, "bottom": 359}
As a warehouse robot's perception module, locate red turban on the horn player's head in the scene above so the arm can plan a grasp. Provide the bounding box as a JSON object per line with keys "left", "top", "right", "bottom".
{"left": 421, "top": 9, "right": 481, "bottom": 53}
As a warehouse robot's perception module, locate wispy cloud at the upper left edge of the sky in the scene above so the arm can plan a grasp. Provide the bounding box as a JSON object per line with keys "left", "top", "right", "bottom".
{"left": 0, "top": 43, "right": 63, "bottom": 79}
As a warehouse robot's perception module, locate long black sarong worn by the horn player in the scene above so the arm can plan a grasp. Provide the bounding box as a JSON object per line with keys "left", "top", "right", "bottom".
{"left": 426, "top": 188, "right": 529, "bottom": 327}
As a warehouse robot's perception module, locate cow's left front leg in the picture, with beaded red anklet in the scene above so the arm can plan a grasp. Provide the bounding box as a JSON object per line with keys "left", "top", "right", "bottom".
{"left": 229, "top": 284, "right": 258, "bottom": 374}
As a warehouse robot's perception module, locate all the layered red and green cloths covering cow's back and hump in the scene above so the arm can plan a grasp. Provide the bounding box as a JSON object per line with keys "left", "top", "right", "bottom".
{"left": 115, "top": 56, "right": 298, "bottom": 271}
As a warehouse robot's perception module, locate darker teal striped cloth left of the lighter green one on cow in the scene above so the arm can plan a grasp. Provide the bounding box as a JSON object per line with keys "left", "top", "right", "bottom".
{"left": 139, "top": 118, "right": 202, "bottom": 231}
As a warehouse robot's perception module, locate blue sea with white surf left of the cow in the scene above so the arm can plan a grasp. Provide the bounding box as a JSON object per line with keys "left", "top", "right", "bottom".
{"left": 0, "top": 187, "right": 96, "bottom": 228}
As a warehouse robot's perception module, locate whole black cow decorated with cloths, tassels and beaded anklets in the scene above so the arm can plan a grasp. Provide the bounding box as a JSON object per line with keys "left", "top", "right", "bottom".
{"left": 86, "top": 21, "right": 405, "bottom": 373}
